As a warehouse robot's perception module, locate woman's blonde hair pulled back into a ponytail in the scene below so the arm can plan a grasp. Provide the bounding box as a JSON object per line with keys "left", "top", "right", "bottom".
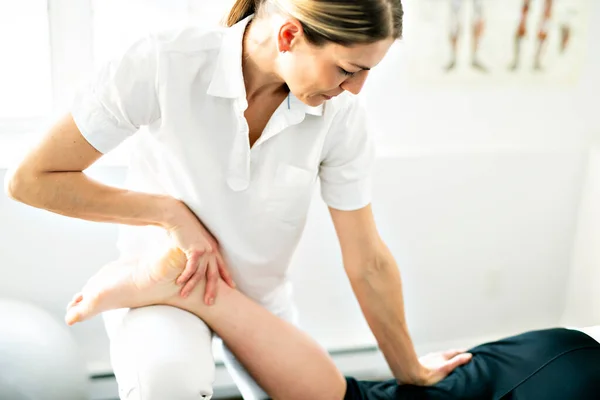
{"left": 224, "top": 0, "right": 404, "bottom": 46}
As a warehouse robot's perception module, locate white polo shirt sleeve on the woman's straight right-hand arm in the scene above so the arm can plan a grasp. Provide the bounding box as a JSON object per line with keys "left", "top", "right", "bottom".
{"left": 319, "top": 96, "right": 375, "bottom": 211}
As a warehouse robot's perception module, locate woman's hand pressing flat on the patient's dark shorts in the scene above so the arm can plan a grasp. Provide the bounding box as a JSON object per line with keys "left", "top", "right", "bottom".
{"left": 414, "top": 350, "right": 473, "bottom": 386}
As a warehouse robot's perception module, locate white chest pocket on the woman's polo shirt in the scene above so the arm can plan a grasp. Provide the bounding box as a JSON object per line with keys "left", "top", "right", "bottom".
{"left": 265, "top": 164, "right": 317, "bottom": 224}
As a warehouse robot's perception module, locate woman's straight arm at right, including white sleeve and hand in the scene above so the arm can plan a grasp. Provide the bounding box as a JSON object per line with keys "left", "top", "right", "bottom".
{"left": 319, "top": 96, "right": 472, "bottom": 385}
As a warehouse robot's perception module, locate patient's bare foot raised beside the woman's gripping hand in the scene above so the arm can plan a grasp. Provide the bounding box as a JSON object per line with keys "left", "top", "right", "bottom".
{"left": 65, "top": 249, "right": 186, "bottom": 325}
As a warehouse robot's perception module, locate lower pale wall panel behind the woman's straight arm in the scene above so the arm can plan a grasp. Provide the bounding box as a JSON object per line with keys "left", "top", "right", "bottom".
{"left": 294, "top": 151, "right": 584, "bottom": 347}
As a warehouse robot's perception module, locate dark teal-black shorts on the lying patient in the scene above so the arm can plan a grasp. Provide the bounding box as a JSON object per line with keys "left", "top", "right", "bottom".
{"left": 345, "top": 328, "right": 600, "bottom": 400}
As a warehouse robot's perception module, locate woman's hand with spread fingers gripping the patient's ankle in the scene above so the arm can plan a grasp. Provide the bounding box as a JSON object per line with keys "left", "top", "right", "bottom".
{"left": 167, "top": 198, "right": 235, "bottom": 305}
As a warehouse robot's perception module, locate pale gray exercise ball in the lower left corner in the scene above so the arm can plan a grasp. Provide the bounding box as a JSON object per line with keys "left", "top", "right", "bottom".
{"left": 0, "top": 299, "right": 90, "bottom": 400}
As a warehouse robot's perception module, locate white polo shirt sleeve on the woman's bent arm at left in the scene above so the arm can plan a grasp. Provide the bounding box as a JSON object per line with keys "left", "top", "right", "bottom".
{"left": 71, "top": 36, "right": 160, "bottom": 153}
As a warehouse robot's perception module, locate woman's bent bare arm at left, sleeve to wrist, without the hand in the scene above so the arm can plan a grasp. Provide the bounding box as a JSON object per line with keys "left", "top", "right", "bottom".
{"left": 6, "top": 115, "right": 180, "bottom": 229}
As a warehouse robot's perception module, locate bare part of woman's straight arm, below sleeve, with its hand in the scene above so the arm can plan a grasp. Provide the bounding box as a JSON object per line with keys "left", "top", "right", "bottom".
{"left": 329, "top": 205, "right": 468, "bottom": 386}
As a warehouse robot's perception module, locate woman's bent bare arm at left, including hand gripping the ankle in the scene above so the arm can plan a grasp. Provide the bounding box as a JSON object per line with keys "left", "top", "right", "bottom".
{"left": 5, "top": 115, "right": 235, "bottom": 304}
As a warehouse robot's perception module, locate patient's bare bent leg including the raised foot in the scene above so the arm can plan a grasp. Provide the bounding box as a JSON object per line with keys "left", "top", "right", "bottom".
{"left": 65, "top": 249, "right": 346, "bottom": 400}
